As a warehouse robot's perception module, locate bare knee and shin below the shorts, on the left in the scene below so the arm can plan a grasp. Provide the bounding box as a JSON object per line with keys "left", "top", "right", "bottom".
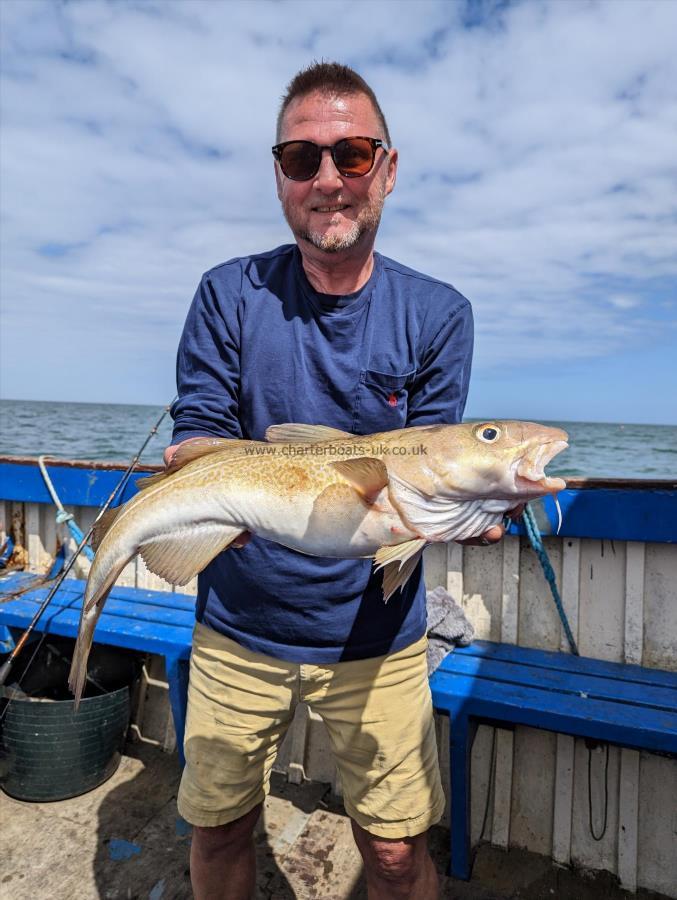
{"left": 190, "top": 803, "right": 263, "bottom": 900}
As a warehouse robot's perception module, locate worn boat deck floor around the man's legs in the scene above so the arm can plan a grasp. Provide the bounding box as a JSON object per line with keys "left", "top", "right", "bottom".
{"left": 0, "top": 744, "right": 666, "bottom": 900}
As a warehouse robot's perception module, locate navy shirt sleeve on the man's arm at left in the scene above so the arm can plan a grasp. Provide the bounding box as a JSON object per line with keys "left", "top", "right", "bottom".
{"left": 171, "top": 273, "right": 242, "bottom": 444}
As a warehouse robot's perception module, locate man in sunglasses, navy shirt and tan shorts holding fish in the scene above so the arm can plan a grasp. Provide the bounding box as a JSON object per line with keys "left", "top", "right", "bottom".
{"left": 167, "top": 63, "right": 502, "bottom": 900}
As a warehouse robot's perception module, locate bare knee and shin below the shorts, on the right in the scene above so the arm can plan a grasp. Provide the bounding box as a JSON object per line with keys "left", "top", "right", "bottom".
{"left": 352, "top": 821, "right": 439, "bottom": 900}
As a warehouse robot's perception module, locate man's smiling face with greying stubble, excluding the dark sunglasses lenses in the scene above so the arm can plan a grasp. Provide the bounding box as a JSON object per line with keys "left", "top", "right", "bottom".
{"left": 275, "top": 93, "right": 397, "bottom": 253}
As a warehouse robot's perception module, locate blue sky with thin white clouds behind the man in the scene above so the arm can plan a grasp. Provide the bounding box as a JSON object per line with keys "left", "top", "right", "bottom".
{"left": 0, "top": 0, "right": 677, "bottom": 424}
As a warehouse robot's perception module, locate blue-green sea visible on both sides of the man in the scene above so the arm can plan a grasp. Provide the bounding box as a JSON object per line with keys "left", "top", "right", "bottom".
{"left": 0, "top": 400, "right": 677, "bottom": 480}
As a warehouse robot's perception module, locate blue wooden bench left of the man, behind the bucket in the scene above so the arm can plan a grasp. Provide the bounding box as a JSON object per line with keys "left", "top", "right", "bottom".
{"left": 0, "top": 573, "right": 195, "bottom": 764}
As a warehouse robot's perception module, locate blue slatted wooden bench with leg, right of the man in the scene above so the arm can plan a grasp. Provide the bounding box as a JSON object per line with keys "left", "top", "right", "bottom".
{"left": 430, "top": 641, "right": 677, "bottom": 880}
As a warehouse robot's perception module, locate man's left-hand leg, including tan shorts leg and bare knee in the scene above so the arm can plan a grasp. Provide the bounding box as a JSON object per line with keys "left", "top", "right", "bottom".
{"left": 178, "top": 625, "right": 298, "bottom": 900}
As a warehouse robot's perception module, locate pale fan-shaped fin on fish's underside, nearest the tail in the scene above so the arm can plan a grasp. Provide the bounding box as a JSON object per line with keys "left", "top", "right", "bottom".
{"left": 139, "top": 522, "right": 244, "bottom": 585}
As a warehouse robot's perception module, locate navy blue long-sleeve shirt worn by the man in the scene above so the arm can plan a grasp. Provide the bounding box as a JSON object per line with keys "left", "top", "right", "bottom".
{"left": 172, "top": 244, "right": 473, "bottom": 663}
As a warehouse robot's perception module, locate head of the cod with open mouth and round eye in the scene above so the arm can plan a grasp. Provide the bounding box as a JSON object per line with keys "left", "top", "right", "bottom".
{"left": 426, "top": 421, "right": 569, "bottom": 503}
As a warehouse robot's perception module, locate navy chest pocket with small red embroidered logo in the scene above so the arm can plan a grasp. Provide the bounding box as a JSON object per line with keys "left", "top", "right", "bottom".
{"left": 352, "top": 369, "right": 416, "bottom": 434}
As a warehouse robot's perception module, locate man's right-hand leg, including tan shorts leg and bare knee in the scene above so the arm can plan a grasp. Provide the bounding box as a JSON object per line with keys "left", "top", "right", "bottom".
{"left": 301, "top": 639, "right": 445, "bottom": 900}
